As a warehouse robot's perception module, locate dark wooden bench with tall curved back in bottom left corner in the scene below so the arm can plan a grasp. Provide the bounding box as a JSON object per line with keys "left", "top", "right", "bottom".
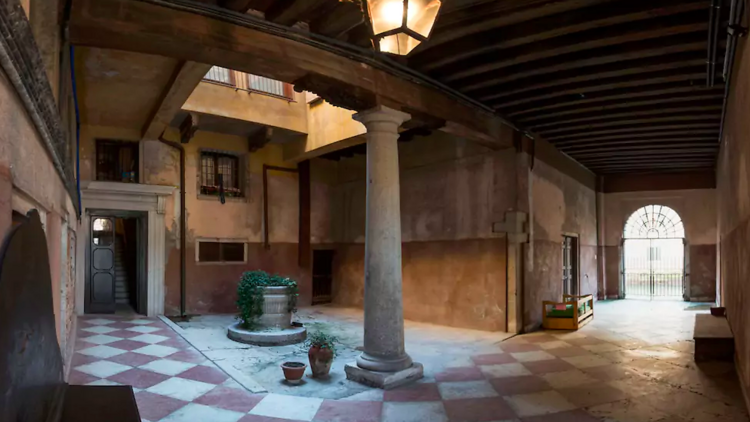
{"left": 0, "top": 211, "right": 141, "bottom": 422}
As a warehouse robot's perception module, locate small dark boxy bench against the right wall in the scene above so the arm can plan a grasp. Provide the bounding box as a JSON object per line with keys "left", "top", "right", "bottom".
{"left": 693, "top": 314, "right": 734, "bottom": 362}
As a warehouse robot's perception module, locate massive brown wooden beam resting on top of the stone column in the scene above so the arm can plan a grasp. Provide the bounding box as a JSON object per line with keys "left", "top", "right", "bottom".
{"left": 69, "top": 0, "right": 512, "bottom": 148}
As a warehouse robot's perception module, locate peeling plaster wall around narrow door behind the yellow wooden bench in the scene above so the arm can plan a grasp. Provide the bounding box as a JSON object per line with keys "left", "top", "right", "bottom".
{"left": 524, "top": 160, "right": 597, "bottom": 330}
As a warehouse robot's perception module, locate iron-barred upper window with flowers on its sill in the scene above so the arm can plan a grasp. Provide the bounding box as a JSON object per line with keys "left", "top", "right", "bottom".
{"left": 201, "top": 151, "right": 242, "bottom": 197}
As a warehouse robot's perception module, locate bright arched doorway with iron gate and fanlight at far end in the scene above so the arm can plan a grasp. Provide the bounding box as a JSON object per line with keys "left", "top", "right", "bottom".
{"left": 623, "top": 205, "right": 685, "bottom": 299}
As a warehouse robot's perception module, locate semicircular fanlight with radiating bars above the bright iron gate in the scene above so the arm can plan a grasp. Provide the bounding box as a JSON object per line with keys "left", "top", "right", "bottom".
{"left": 625, "top": 205, "right": 685, "bottom": 239}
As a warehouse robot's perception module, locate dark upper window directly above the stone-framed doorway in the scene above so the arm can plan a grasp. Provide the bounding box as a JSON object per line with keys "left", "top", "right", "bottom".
{"left": 96, "top": 140, "right": 138, "bottom": 183}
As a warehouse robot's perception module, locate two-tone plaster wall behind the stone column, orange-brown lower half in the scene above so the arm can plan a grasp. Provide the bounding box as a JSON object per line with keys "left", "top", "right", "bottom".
{"left": 333, "top": 133, "right": 515, "bottom": 331}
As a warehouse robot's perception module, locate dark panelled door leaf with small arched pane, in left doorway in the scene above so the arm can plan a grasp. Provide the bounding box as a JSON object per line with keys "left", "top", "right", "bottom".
{"left": 87, "top": 216, "right": 115, "bottom": 313}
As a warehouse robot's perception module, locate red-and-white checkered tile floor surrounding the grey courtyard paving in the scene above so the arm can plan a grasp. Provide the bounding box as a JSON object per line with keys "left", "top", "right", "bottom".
{"left": 70, "top": 301, "right": 748, "bottom": 422}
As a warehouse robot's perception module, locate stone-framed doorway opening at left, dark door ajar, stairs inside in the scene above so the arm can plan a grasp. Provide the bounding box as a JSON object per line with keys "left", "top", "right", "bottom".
{"left": 85, "top": 213, "right": 147, "bottom": 314}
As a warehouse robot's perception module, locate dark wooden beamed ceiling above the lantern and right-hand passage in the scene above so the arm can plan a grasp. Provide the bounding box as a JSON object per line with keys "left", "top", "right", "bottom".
{"left": 198, "top": 0, "right": 728, "bottom": 174}
